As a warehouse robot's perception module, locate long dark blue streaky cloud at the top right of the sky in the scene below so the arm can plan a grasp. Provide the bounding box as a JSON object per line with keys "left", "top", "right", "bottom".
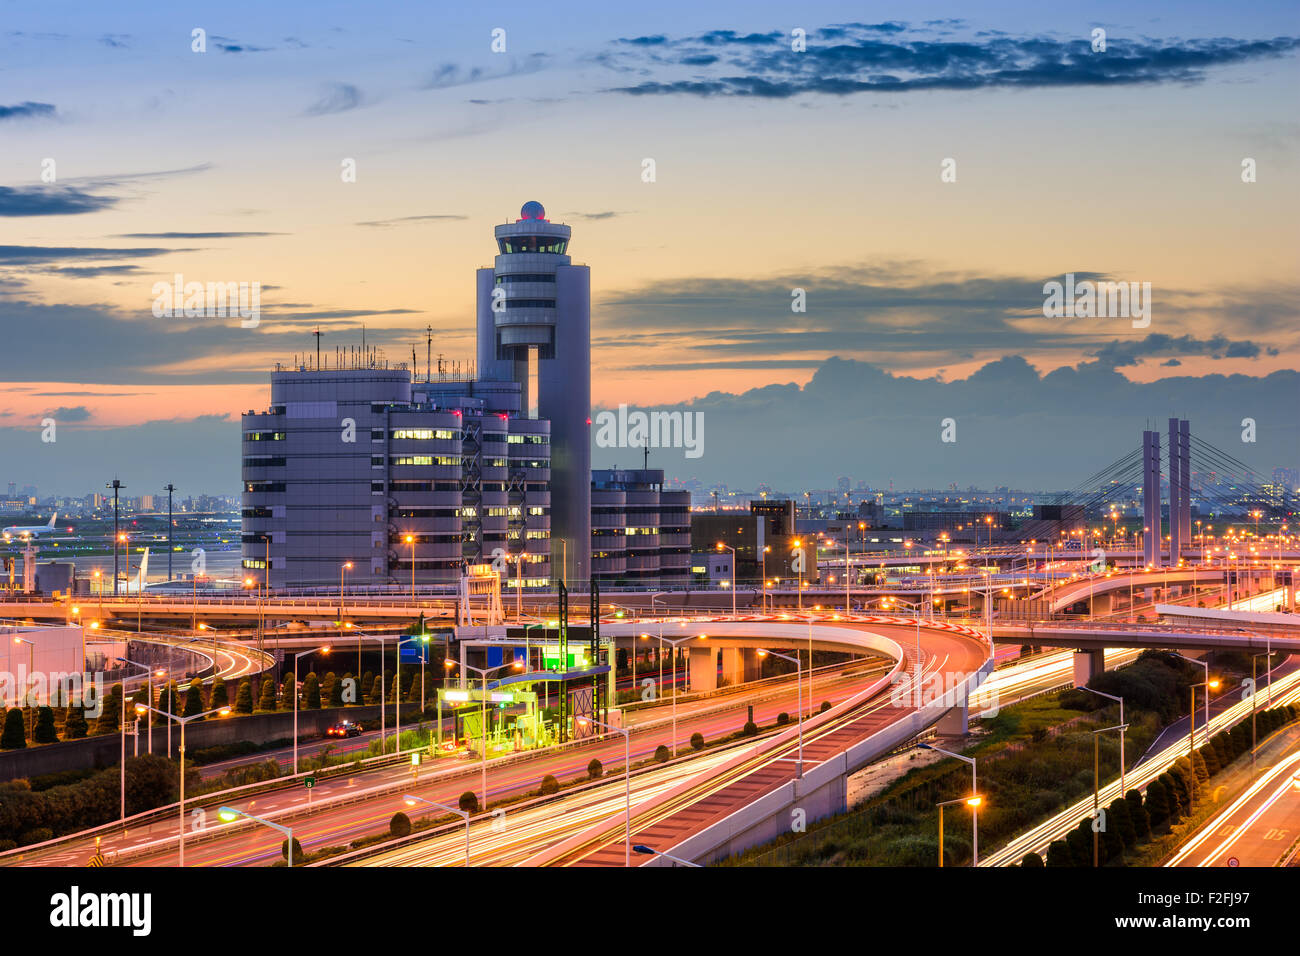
{"left": 595, "top": 22, "right": 1300, "bottom": 99}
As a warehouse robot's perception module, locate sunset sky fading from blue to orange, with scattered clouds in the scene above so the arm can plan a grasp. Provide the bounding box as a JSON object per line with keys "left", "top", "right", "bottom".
{"left": 0, "top": 0, "right": 1300, "bottom": 502}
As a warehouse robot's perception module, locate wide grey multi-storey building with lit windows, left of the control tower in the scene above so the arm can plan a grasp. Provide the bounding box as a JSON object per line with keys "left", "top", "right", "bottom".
{"left": 242, "top": 358, "right": 551, "bottom": 588}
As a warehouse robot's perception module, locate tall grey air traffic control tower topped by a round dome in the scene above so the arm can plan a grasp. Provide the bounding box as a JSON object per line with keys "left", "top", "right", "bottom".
{"left": 478, "top": 202, "right": 592, "bottom": 587}
